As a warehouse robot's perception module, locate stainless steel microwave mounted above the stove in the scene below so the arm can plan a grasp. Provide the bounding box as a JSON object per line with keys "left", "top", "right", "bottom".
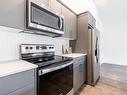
{"left": 26, "top": 0, "right": 64, "bottom": 35}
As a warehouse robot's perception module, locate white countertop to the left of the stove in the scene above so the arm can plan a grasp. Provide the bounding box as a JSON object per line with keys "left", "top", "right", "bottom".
{"left": 0, "top": 60, "right": 38, "bottom": 77}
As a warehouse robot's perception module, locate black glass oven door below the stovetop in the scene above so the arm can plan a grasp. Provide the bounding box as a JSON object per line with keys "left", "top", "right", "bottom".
{"left": 38, "top": 62, "right": 73, "bottom": 95}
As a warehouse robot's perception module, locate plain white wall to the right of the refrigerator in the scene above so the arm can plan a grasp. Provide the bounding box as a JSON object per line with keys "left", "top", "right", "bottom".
{"left": 101, "top": 21, "right": 127, "bottom": 65}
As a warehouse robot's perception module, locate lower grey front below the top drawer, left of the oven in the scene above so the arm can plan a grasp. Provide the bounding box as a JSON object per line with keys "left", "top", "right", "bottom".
{"left": 8, "top": 84, "right": 36, "bottom": 95}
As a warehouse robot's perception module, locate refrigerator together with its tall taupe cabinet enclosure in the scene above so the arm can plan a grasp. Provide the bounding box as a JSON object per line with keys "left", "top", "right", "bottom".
{"left": 75, "top": 12, "right": 100, "bottom": 85}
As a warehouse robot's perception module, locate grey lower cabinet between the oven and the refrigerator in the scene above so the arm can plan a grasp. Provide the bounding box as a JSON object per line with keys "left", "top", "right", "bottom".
{"left": 73, "top": 56, "right": 86, "bottom": 93}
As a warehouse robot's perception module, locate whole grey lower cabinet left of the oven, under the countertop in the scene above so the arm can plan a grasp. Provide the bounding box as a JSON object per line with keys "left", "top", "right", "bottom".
{"left": 0, "top": 69, "right": 36, "bottom": 95}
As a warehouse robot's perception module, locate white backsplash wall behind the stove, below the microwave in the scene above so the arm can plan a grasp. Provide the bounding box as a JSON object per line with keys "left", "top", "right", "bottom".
{"left": 0, "top": 26, "right": 69, "bottom": 62}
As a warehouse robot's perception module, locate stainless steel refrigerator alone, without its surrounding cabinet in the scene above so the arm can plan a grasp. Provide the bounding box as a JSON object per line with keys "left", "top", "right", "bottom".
{"left": 86, "top": 28, "right": 100, "bottom": 85}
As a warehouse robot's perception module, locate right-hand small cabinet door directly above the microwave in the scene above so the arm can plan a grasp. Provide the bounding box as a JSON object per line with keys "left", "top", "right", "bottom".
{"left": 50, "top": 0, "right": 62, "bottom": 15}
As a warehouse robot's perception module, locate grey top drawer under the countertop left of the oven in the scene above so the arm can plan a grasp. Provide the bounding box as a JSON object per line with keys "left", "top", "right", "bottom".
{"left": 0, "top": 70, "right": 34, "bottom": 95}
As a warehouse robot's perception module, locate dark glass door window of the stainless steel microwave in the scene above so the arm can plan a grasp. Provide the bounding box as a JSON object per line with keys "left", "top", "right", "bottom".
{"left": 30, "top": 3, "right": 60, "bottom": 30}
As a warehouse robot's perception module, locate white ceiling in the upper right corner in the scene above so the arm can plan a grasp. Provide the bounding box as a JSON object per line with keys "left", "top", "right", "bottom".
{"left": 93, "top": 0, "right": 127, "bottom": 24}
